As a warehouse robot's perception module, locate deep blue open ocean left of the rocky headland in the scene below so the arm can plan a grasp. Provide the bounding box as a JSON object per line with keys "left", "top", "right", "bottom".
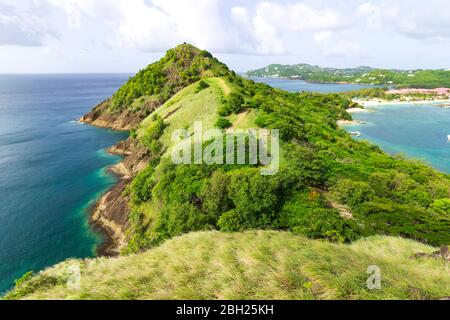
{"left": 0, "top": 75, "right": 128, "bottom": 293}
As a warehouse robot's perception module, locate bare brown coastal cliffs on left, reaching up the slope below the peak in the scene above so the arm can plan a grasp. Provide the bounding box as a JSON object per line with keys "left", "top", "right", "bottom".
{"left": 80, "top": 95, "right": 156, "bottom": 256}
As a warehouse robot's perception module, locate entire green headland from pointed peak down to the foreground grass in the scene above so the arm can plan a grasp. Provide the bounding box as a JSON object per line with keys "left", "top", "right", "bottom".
{"left": 5, "top": 44, "right": 450, "bottom": 299}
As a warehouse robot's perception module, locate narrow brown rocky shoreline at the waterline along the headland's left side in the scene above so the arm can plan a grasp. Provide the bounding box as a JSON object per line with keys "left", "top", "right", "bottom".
{"left": 80, "top": 114, "right": 149, "bottom": 256}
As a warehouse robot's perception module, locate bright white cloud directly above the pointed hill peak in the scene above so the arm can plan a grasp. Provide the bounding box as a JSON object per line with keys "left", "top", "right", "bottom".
{"left": 111, "top": 0, "right": 285, "bottom": 54}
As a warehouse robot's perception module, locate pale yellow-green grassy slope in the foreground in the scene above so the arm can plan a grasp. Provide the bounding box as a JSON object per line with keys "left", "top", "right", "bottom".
{"left": 6, "top": 231, "right": 450, "bottom": 299}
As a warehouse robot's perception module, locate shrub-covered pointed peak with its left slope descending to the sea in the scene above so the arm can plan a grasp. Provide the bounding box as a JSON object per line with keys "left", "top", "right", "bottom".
{"left": 80, "top": 43, "right": 230, "bottom": 130}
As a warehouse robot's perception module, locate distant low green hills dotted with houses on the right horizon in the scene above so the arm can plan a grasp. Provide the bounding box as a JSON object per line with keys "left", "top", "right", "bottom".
{"left": 247, "top": 64, "right": 450, "bottom": 88}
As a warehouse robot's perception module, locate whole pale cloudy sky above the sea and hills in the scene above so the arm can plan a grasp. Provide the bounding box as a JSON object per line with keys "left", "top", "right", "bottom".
{"left": 0, "top": 0, "right": 450, "bottom": 73}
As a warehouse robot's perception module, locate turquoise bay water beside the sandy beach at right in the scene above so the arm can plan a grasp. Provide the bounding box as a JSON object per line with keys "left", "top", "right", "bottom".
{"left": 345, "top": 104, "right": 450, "bottom": 173}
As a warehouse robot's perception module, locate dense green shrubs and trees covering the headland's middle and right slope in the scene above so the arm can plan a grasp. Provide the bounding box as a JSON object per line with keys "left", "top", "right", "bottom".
{"left": 126, "top": 65, "right": 450, "bottom": 252}
